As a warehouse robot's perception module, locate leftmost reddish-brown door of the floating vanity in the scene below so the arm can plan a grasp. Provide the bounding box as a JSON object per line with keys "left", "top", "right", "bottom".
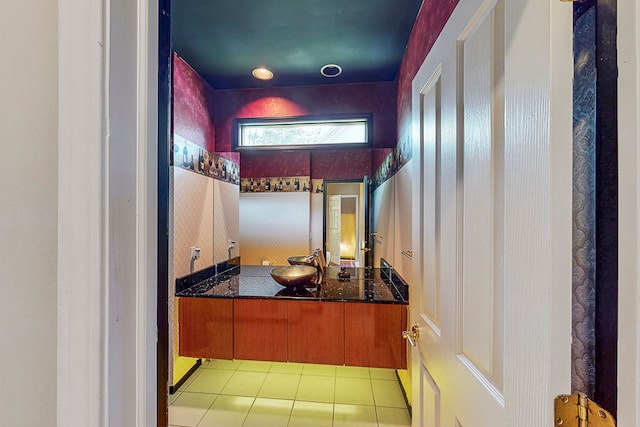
{"left": 178, "top": 297, "right": 233, "bottom": 359}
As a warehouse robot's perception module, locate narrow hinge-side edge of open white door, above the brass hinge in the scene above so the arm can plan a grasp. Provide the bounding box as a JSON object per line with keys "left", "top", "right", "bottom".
{"left": 546, "top": 1, "right": 573, "bottom": 404}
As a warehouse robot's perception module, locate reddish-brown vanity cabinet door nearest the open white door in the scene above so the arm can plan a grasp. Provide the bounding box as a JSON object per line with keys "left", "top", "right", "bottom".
{"left": 344, "top": 303, "right": 407, "bottom": 369}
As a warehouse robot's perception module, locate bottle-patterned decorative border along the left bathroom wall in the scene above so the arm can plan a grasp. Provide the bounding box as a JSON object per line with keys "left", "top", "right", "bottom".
{"left": 171, "top": 134, "right": 240, "bottom": 184}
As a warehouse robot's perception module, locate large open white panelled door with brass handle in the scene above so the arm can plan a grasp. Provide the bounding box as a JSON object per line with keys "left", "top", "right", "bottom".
{"left": 410, "top": 0, "right": 572, "bottom": 427}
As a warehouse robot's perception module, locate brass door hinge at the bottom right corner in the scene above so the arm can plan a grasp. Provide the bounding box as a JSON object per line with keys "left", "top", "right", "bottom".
{"left": 553, "top": 393, "right": 616, "bottom": 427}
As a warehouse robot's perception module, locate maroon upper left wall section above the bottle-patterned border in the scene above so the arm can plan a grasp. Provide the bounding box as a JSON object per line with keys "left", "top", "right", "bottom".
{"left": 173, "top": 53, "right": 216, "bottom": 152}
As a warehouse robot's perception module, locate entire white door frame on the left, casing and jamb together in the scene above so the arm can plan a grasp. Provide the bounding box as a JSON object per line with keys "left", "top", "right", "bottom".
{"left": 57, "top": 0, "right": 158, "bottom": 427}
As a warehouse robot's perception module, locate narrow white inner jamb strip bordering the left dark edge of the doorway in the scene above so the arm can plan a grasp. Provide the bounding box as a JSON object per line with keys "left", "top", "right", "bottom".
{"left": 136, "top": 0, "right": 158, "bottom": 426}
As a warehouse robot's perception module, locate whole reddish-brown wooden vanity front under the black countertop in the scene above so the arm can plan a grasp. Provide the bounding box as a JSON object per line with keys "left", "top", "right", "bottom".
{"left": 178, "top": 297, "right": 407, "bottom": 369}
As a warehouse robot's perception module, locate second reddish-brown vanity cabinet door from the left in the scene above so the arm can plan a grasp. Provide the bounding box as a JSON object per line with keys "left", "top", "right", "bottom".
{"left": 233, "top": 299, "right": 287, "bottom": 362}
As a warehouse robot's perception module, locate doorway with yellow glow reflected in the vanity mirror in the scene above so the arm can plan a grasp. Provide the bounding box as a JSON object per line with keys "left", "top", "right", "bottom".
{"left": 324, "top": 181, "right": 367, "bottom": 267}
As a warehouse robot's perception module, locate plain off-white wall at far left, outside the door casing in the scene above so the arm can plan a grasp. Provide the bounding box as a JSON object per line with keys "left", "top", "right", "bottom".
{"left": 0, "top": 0, "right": 58, "bottom": 427}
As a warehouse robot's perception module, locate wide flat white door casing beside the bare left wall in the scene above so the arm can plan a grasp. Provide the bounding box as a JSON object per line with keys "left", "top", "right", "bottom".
{"left": 57, "top": 0, "right": 107, "bottom": 427}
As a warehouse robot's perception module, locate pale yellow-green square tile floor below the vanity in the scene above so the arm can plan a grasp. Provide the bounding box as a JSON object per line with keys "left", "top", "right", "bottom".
{"left": 169, "top": 360, "right": 411, "bottom": 427}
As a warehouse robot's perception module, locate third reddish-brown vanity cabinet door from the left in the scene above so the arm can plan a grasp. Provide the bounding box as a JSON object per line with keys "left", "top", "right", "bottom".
{"left": 287, "top": 301, "right": 344, "bottom": 365}
